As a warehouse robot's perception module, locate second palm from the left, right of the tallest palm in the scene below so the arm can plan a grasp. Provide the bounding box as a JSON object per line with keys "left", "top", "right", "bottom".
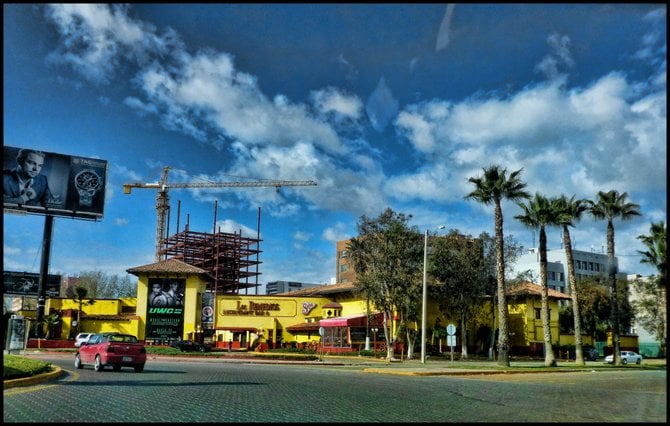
{"left": 514, "top": 193, "right": 557, "bottom": 367}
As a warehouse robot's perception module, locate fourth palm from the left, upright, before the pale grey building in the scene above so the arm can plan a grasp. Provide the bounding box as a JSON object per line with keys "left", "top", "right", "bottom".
{"left": 588, "top": 190, "right": 640, "bottom": 365}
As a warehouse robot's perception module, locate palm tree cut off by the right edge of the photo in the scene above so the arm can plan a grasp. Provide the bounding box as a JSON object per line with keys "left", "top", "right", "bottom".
{"left": 637, "top": 221, "right": 668, "bottom": 358}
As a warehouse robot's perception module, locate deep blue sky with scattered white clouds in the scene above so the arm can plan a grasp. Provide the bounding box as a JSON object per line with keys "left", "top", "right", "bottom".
{"left": 3, "top": 4, "right": 667, "bottom": 291}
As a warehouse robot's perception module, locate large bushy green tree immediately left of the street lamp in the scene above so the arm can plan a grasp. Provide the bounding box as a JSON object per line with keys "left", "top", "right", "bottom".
{"left": 348, "top": 208, "right": 423, "bottom": 360}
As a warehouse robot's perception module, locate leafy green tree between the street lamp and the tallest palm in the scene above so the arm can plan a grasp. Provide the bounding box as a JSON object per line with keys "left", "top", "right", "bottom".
{"left": 428, "top": 230, "right": 487, "bottom": 359}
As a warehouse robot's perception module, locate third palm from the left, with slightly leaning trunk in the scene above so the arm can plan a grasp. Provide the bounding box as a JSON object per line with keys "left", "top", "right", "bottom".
{"left": 552, "top": 195, "right": 588, "bottom": 365}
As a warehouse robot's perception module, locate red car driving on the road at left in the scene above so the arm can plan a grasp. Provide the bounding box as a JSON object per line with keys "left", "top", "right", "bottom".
{"left": 74, "top": 333, "right": 147, "bottom": 373}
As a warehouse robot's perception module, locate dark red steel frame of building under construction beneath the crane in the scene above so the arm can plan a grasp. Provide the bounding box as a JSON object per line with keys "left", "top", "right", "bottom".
{"left": 161, "top": 226, "right": 261, "bottom": 294}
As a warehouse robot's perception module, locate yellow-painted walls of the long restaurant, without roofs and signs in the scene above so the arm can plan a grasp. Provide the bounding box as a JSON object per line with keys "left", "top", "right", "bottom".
{"left": 39, "top": 274, "right": 633, "bottom": 354}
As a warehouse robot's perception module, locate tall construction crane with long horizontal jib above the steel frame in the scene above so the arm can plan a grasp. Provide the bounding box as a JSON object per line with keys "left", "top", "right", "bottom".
{"left": 123, "top": 166, "right": 316, "bottom": 262}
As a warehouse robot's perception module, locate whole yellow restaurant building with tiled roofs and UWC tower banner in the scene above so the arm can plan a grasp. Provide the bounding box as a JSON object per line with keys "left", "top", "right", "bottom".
{"left": 26, "top": 253, "right": 584, "bottom": 355}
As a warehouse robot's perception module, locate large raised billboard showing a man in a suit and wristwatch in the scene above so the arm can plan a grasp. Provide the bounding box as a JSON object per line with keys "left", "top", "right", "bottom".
{"left": 2, "top": 146, "right": 107, "bottom": 220}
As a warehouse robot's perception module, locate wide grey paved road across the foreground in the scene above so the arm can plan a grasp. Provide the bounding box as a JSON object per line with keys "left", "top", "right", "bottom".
{"left": 3, "top": 356, "right": 667, "bottom": 423}
